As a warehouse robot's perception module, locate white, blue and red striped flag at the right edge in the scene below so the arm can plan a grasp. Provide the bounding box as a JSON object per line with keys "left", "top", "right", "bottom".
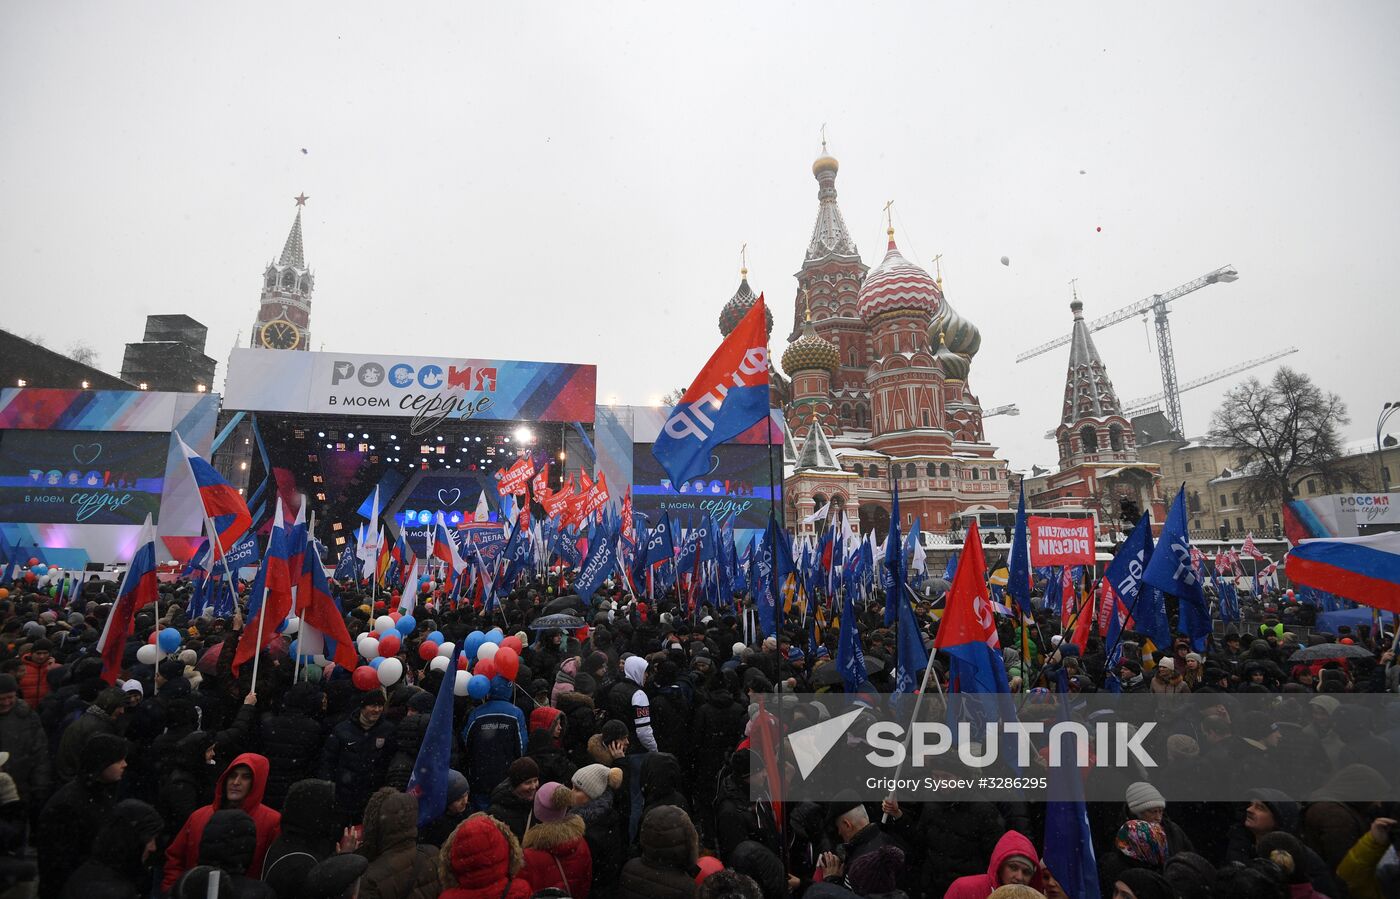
{"left": 1284, "top": 531, "right": 1400, "bottom": 612}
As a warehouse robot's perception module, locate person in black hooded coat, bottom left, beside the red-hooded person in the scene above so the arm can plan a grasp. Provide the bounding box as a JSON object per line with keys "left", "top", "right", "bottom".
{"left": 63, "top": 800, "right": 164, "bottom": 899}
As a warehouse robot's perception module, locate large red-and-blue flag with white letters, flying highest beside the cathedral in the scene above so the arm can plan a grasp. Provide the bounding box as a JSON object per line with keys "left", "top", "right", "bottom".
{"left": 651, "top": 295, "right": 769, "bottom": 485}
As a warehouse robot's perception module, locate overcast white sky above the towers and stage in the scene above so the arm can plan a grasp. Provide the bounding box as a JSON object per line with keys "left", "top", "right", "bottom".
{"left": 0, "top": 0, "right": 1400, "bottom": 468}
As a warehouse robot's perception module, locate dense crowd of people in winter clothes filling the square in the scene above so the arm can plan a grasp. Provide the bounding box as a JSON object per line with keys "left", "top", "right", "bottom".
{"left": 0, "top": 571, "right": 1400, "bottom": 899}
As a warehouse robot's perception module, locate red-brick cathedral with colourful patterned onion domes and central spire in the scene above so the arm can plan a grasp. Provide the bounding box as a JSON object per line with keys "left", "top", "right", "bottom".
{"left": 720, "top": 146, "right": 1011, "bottom": 535}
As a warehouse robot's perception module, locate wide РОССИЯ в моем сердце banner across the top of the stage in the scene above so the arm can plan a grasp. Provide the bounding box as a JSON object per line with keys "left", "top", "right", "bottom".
{"left": 224, "top": 349, "right": 598, "bottom": 425}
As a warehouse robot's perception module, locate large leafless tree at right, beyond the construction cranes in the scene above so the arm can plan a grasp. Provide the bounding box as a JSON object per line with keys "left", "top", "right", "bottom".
{"left": 1211, "top": 365, "right": 1355, "bottom": 510}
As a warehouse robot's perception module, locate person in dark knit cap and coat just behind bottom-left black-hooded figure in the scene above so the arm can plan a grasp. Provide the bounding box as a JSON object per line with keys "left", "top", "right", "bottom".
{"left": 35, "top": 734, "right": 126, "bottom": 899}
